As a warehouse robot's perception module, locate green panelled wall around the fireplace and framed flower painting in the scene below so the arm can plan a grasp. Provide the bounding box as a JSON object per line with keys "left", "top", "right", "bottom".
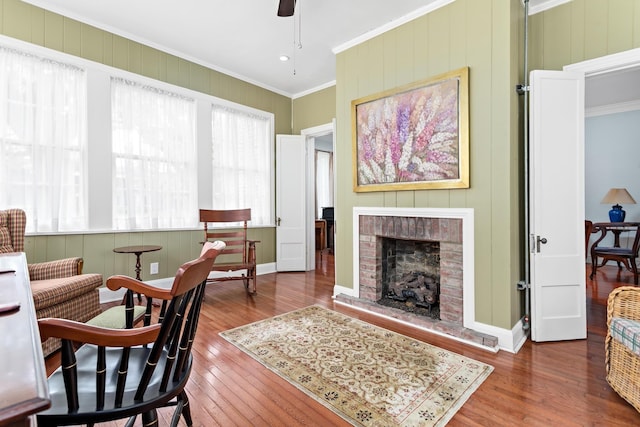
{"left": 336, "top": 0, "right": 522, "bottom": 329}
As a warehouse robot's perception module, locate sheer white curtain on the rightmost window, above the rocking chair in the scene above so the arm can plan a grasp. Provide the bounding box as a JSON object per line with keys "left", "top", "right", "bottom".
{"left": 211, "top": 105, "right": 273, "bottom": 225}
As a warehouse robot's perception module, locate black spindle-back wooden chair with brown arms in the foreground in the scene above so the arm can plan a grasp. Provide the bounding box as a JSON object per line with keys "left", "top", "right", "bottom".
{"left": 37, "top": 242, "right": 224, "bottom": 427}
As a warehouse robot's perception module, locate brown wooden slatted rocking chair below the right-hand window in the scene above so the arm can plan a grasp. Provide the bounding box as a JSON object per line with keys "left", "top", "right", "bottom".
{"left": 200, "top": 209, "right": 259, "bottom": 294}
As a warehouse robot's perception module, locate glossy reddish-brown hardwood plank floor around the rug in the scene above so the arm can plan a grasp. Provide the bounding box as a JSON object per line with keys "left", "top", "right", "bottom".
{"left": 47, "top": 256, "right": 640, "bottom": 427}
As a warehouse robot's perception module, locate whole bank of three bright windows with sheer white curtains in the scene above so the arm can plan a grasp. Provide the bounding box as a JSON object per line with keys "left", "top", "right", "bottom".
{"left": 0, "top": 35, "right": 275, "bottom": 234}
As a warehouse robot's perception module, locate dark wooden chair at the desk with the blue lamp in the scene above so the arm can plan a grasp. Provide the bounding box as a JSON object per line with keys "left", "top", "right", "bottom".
{"left": 589, "top": 222, "right": 640, "bottom": 285}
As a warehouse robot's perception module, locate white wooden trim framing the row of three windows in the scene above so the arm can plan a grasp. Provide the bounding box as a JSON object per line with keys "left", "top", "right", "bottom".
{"left": 0, "top": 34, "right": 275, "bottom": 235}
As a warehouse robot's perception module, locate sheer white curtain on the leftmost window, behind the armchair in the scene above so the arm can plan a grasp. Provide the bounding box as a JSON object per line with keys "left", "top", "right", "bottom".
{"left": 0, "top": 47, "right": 88, "bottom": 232}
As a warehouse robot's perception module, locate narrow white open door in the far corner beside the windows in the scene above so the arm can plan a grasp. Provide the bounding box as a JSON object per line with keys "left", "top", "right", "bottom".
{"left": 276, "top": 135, "right": 307, "bottom": 271}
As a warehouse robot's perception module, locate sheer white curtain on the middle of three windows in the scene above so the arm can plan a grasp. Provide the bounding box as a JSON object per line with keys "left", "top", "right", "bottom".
{"left": 111, "top": 78, "right": 198, "bottom": 230}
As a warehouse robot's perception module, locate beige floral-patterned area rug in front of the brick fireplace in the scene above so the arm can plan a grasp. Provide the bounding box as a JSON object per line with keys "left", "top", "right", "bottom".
{"left": 220, "top": 306, "right": 493, "bottom": 426}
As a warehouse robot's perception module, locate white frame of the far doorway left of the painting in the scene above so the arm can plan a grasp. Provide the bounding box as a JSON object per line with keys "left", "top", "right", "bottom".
{"left": 300, "top": 119, "right": 336, "bottom": 271}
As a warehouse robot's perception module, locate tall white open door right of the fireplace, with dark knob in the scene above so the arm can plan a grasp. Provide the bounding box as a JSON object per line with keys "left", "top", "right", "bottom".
{"left": 529, "top": 71, "right": 587, "bottom": 341}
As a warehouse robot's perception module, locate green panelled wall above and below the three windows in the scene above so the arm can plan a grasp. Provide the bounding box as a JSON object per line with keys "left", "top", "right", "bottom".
{"left": 0, "top": 0, "right": 292, "bottom": 280}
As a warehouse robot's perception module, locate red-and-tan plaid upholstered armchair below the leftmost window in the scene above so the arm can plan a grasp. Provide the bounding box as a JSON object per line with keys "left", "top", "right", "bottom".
{"left": 0, "top": 209, "right": 102, "bottom": 356}
